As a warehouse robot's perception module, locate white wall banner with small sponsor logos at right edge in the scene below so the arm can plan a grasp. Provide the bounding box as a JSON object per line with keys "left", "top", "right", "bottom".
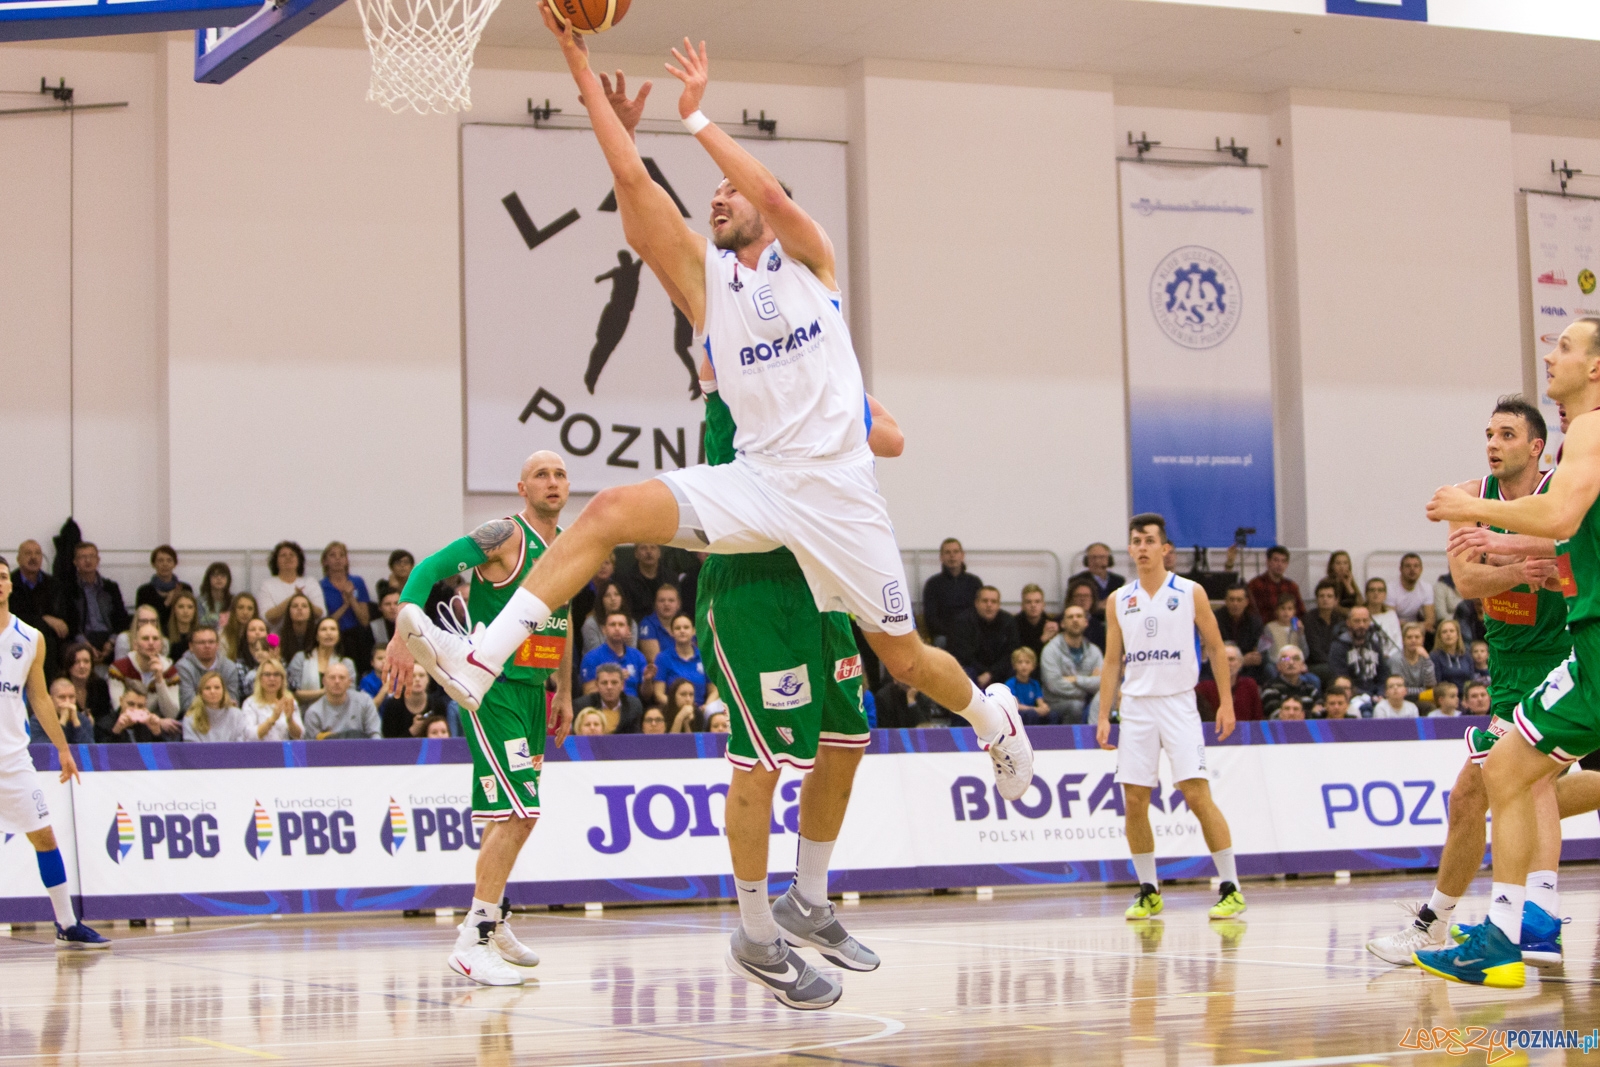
{"left": 1528, "top": 192, "right": 1600, "bottom": 458}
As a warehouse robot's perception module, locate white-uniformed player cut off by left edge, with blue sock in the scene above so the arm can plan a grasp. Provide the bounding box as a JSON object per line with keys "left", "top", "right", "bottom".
{"left": 0, "top": 558, "right": 110, "bottom": 949}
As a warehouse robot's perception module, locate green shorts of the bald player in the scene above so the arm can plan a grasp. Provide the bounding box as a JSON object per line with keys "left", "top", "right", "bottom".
{"left": 461, "top": 678, "right": 544, "bottom": 822}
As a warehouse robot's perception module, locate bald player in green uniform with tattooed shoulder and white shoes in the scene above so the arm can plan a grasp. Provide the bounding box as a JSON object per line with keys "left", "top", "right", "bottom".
{"left": 384, "top": 451, "right": 573, "bottom": 985}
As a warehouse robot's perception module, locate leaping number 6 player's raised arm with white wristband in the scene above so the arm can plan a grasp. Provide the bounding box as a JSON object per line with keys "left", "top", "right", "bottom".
{"left": 667, "top": 37, "right": 838, "bottom": 290}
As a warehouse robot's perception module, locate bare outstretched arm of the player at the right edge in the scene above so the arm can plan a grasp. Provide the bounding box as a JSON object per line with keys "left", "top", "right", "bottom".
{"left": 1427, "top": 411, "right": 1600, "bottom": 541}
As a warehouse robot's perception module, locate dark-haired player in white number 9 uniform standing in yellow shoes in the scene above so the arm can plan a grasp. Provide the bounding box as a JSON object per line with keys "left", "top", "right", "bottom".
{"left": 1094, "top": 515, "right": 1245, "bottom": 918}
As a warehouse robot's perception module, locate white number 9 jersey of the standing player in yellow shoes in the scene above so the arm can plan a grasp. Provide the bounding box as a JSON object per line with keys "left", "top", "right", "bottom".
{"left": 1107, "top": 574, "right": 1200, "bottom": 696}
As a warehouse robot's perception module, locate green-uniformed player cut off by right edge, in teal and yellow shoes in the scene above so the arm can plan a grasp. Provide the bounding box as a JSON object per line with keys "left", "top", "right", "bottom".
{"left": 1414, "top": 318, "right": 1600, "bottom": 989}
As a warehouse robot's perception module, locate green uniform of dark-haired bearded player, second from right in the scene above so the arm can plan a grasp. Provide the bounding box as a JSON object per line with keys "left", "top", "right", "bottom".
{"left": 1467, "top": 470, "right": 1573, "bottom": 763}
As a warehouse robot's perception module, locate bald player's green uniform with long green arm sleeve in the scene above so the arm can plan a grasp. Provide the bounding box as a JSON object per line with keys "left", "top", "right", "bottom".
{"left": 400, "top": 515, "right": 571, "bottom": 821}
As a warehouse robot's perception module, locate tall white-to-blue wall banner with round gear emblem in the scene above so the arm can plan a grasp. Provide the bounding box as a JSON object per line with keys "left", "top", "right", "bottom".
{"left": 1118, "top": 162, "right": 1277, "bottom": 547}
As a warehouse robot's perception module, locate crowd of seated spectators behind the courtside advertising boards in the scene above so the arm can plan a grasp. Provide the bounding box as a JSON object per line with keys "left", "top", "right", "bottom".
{"left": 10, "top": 539, "right": 1488, "bottom": 744}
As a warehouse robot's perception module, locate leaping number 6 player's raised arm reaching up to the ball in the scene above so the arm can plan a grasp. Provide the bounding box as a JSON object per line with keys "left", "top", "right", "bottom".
{"left": 539, "top": 2, "right": 706, "bottom": 326}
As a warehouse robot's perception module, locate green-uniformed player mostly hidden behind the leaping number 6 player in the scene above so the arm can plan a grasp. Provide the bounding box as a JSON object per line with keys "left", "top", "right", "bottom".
{"left": 600, "top": 70, "right": 906, "bottom": 1008}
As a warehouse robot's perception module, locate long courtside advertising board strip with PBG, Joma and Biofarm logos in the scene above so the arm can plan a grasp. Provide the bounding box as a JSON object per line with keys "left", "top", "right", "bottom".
{"left": 0, "top": 718, "right": 1600, "bottom": 921}
